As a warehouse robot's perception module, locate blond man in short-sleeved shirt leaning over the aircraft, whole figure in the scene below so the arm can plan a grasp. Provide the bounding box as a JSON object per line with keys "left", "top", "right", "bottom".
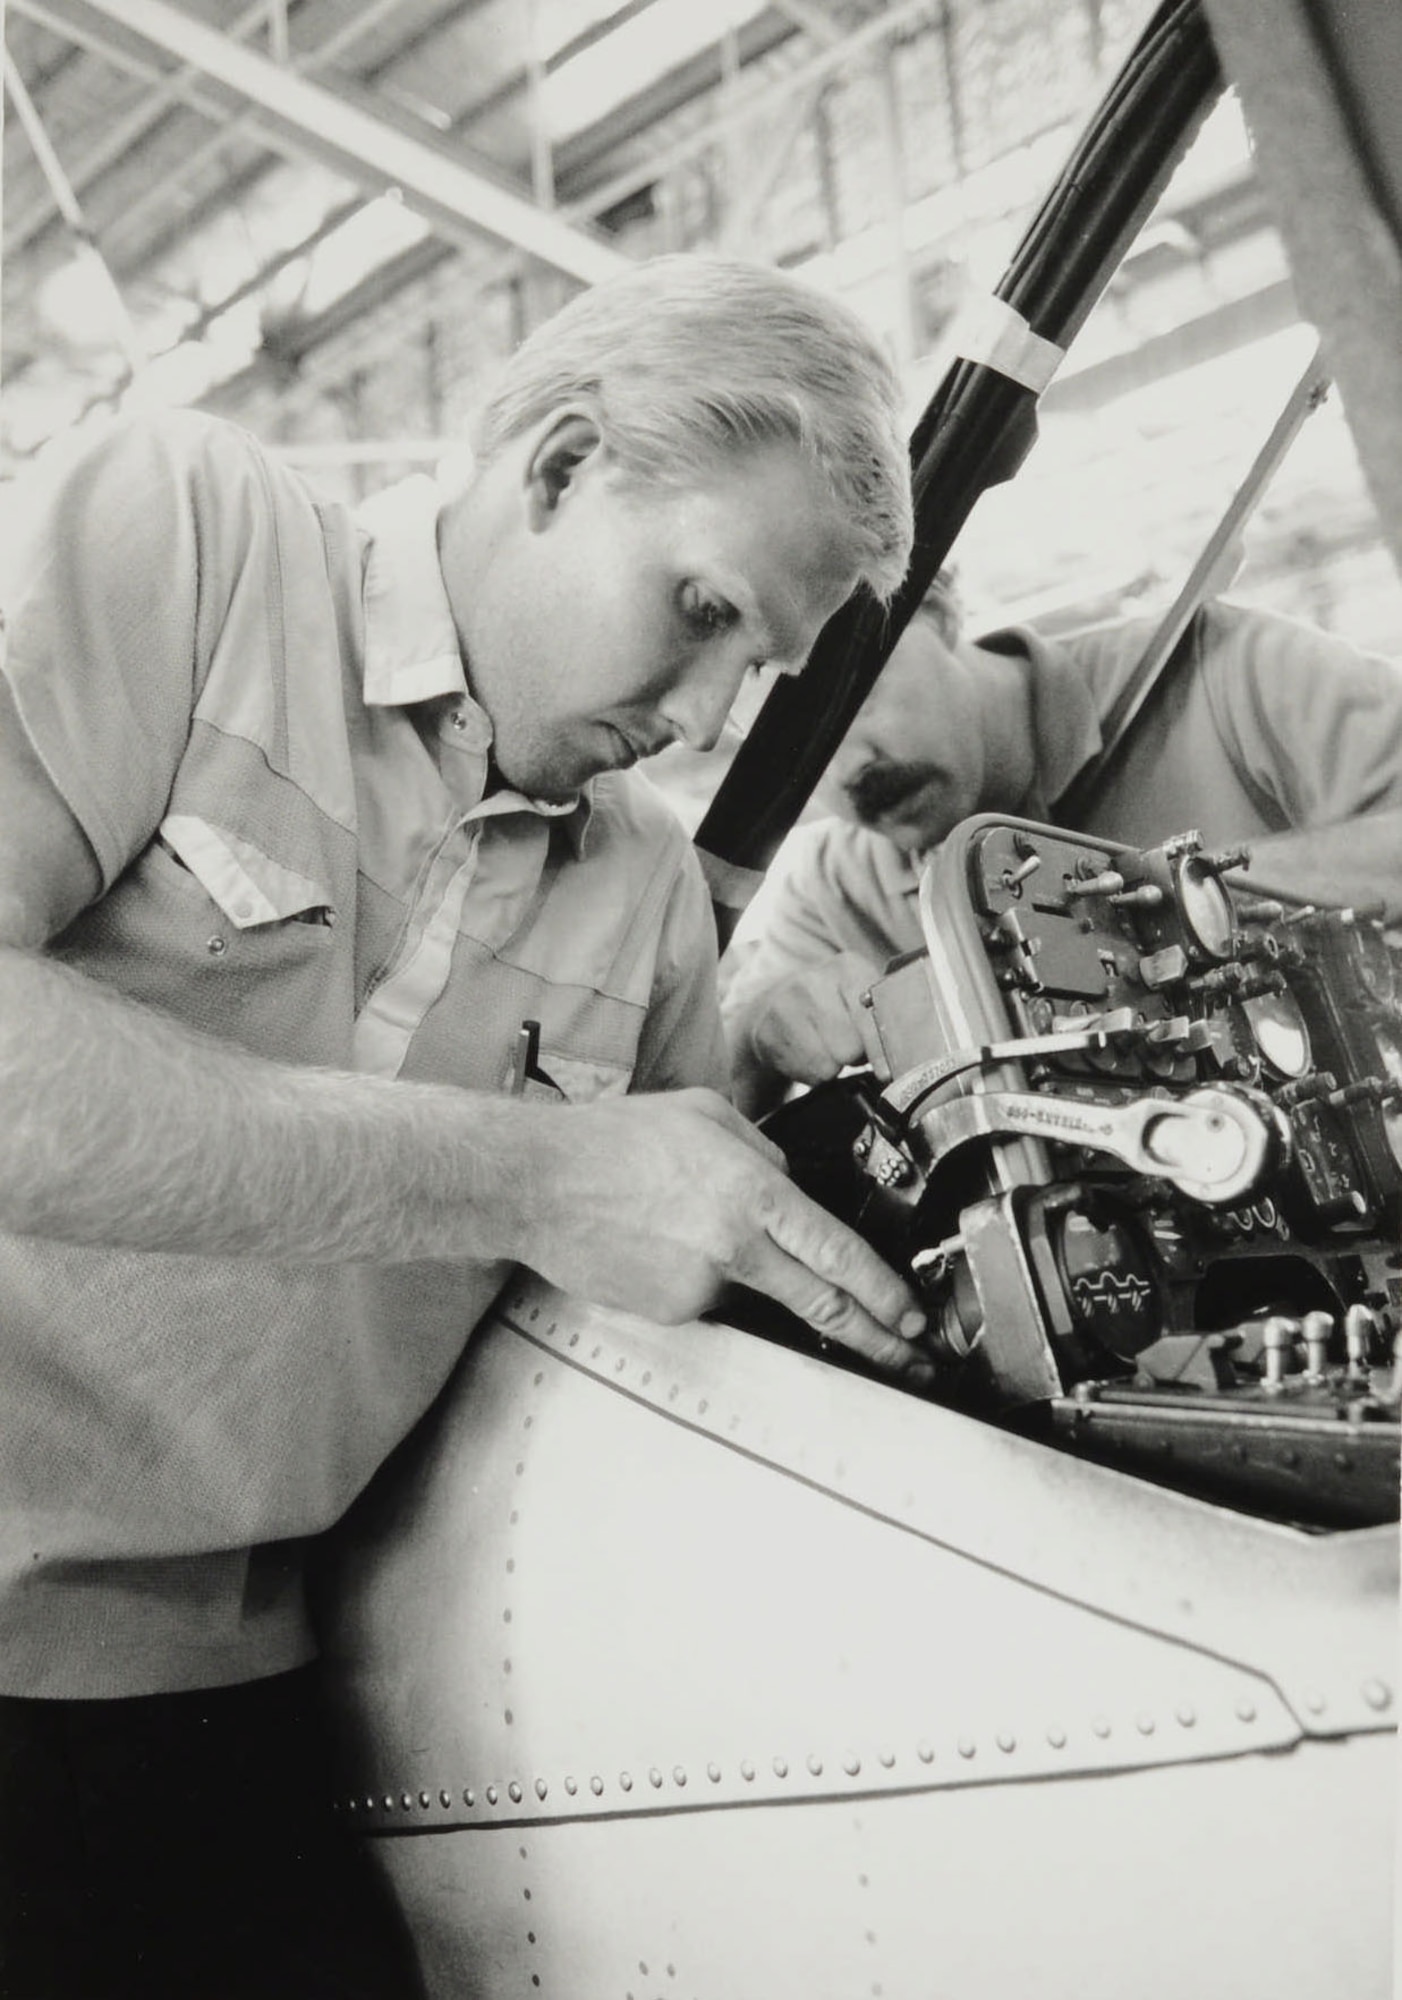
{"left": 0, "top": 258, "right": 920, "bottom": 2000}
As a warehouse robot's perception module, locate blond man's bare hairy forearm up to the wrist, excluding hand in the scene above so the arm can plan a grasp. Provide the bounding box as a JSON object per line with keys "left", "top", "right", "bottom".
{"left": 0, "top": 950, "right": 538, "bottom": 1262}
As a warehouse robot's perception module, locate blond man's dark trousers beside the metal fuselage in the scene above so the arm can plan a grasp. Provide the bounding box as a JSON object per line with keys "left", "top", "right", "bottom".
{"left": 0, "top": 1668, "right": 420, "bottom": 2000}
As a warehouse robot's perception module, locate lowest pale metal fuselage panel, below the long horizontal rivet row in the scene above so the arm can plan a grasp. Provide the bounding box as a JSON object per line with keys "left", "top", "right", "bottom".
{"left": 374, "top": 1736, "right": 1396, "bottom": 2000}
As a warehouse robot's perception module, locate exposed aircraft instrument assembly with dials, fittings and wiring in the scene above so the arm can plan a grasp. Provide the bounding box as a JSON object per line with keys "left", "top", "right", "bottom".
{"left": 768, "top": 816, "right": 1402, "bottom": 1528}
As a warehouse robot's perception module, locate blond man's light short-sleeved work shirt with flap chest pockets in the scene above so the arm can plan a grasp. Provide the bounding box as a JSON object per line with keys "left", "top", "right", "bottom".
{"left": 0, "top": 412, "right": 724, "bottom": 1696}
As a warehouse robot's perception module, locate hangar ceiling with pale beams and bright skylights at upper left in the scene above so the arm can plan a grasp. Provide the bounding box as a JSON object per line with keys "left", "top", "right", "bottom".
{"left": 4, "top": 0, "right": 964, "bottom": 450}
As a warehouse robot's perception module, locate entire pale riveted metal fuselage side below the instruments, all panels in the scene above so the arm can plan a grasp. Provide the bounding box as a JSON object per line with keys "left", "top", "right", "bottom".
{"left": 328, "top": 1280, "right": 1396, "bottom": 2000}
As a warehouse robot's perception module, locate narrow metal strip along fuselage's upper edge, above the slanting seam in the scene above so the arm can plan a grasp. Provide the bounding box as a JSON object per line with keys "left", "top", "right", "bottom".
{"left": 478, "top": 1278, "right": 1398, "bottom": 1734}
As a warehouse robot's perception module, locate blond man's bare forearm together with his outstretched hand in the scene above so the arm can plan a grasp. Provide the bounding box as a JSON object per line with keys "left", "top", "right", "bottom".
{"left": 0, "top": 948, "right": 922, "bottom": 1368}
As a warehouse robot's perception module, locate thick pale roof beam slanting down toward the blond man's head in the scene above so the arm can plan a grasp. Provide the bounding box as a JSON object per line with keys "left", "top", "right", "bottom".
{"left": 26, "top": 0, "right": 630, "bottom": 284}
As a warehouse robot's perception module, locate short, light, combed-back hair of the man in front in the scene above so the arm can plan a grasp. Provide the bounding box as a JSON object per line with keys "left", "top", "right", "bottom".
{"left": 472, "top": 256, "right": 912, "bottom": 602}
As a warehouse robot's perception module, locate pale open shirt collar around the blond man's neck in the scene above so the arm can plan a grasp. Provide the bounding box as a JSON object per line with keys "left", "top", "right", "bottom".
{"left": 356, "top": 472, "right": 592, "bottom": 854}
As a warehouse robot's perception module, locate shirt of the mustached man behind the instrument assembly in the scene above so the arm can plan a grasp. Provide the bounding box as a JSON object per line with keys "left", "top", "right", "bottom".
{"left": 722, "top": 602, "right": 1402, "bottom": 1018}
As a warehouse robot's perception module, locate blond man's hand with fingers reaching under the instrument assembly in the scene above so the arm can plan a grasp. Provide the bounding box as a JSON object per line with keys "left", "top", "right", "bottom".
{"left": 518, "top": 1090, "right": 926, "bottom": 1372}
